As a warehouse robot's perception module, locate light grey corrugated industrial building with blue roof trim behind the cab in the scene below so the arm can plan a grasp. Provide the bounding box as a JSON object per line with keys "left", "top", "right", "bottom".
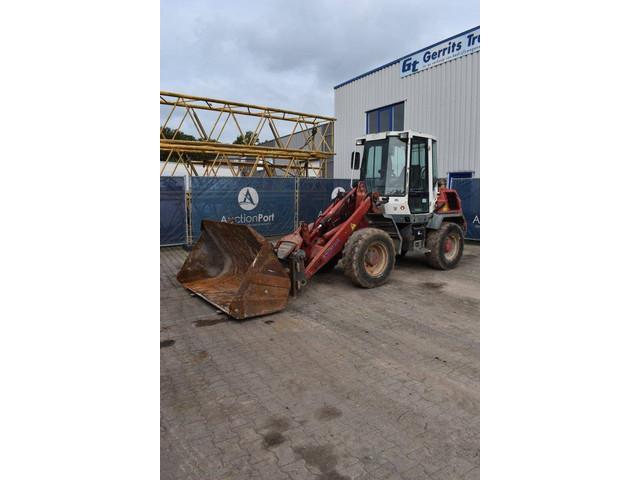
{"left": 330, "top": 26, "right": 480, "bottom": 184}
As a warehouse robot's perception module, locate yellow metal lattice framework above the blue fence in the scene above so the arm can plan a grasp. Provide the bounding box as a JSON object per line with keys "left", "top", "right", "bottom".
{"left": 160, "top": 91, "right": 335, "bottom": 177}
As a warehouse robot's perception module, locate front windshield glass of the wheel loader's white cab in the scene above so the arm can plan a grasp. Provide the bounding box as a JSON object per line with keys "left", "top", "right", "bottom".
{"left": 360, "top": 137, "right": 407, "bottom": 195}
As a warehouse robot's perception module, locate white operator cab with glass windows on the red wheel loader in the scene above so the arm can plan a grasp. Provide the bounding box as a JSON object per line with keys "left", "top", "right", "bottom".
{"left": 351, "top": 130, "right": 438, "bottom": 215}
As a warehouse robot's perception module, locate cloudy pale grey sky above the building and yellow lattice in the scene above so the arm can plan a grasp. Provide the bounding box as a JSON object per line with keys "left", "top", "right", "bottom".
{"left": 160, "top": 0, "right": 480, "bottom": 133}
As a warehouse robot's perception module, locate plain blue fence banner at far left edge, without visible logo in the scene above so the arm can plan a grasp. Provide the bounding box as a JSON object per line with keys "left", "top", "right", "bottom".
{"left": 160, "top": 177, "right": 187, "bottom": 245}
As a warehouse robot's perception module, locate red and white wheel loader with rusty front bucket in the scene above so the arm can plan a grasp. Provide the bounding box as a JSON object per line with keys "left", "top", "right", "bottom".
{"left": 178, "top": 130, "right": 467, "bottom": 319}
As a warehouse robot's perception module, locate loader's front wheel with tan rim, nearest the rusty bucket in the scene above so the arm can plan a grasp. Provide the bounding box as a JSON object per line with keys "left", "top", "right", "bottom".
{"left": 342, "top": 228, "right": 395, "bottom": 288}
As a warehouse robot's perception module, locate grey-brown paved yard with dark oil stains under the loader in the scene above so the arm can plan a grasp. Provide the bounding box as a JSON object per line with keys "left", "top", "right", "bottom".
{"left": 160, "top": 245, "right": 480, "bottom": 480}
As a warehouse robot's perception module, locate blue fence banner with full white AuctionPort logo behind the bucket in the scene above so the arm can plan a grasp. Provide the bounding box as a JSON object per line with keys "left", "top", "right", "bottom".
{"left": 191, "top": 177, "right": 296, "bottom": 242}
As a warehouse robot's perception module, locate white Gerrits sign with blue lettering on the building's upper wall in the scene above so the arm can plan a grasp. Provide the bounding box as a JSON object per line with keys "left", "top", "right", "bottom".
{"left": 400, "top": 27, "right": 480, "bottom": 78}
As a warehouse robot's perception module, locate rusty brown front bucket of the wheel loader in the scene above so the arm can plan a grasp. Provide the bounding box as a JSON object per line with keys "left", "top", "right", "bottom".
{"left": 178, "top": 220, "right": 291, "bottom": 320}
